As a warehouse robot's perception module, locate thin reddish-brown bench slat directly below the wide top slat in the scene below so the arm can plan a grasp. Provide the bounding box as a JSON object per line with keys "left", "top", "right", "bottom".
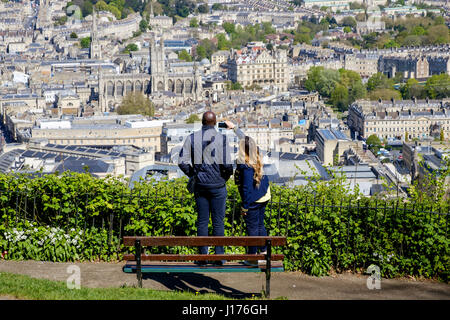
{"left": 123, "top": 254, "right": 284, "bottom": 261}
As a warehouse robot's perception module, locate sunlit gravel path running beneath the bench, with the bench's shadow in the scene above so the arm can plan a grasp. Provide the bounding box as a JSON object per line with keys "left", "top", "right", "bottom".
{"left": 0, "top": 260, "right": 450, "bottom": 300}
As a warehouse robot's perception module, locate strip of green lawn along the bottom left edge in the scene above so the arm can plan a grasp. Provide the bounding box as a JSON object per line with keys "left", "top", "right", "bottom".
{"left": 0, "top": 272, "right": 230, "bottom": 300}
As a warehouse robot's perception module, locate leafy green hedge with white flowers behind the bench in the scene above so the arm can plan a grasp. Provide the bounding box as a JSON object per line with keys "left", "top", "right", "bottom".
{"left": 0, "top": 173, "right": 450, "bottom": 281}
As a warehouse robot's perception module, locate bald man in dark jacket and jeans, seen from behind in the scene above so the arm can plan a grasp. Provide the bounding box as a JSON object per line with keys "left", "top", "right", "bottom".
{"left": 178, "top": 111, "right": 233, "bottom": 264}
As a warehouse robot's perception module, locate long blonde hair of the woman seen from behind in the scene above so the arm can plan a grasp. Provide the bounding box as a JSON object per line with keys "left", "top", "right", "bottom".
{"left": 237, "top": 136, "right": 263, "bottom": 188}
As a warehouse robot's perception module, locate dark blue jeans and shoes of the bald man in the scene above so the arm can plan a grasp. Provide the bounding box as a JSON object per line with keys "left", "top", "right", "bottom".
{"left": 194, "top": 186, "right": 227, "bottom": 254}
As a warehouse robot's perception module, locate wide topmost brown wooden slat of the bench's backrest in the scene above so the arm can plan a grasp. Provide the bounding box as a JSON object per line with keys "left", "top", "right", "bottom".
{"left": 123, "top": 236, "right": 286, "bottom": 247}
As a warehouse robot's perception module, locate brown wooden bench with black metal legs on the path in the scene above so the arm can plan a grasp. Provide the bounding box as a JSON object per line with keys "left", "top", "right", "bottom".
{"left": 123, "top": 236, "right": 286, "bottom": 297}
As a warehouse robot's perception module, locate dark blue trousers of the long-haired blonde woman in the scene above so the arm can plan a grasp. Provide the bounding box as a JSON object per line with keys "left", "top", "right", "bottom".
{"left": 244, "top": 202, "right": 267, "bottom": 254}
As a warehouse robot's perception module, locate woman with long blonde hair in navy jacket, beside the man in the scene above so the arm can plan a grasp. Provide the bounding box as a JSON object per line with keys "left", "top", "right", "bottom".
{"left": 235, "top": 136, "right": 270, "bottom": 264}
